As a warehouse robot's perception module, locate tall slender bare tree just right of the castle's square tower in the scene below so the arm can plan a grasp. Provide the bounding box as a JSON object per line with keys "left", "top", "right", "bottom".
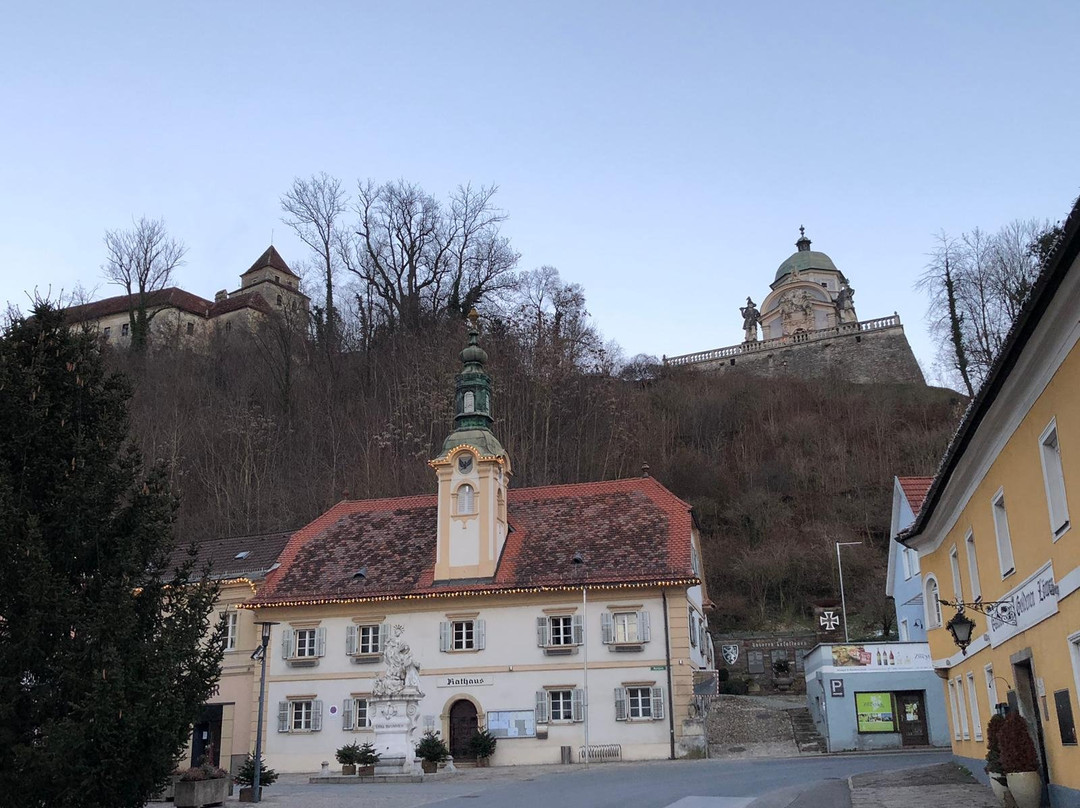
{"left": 281, "top": 172, "right": 349, "bottom": 351}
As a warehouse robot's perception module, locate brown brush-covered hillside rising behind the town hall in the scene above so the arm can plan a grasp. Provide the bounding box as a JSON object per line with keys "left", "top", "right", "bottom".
{"left": 112, "top": 325, "right": 962, "bottom": 628}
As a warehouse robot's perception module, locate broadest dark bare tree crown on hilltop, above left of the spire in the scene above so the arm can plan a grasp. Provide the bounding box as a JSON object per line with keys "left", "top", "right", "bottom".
{"left": 341, "top": 180, "right": 518, "bottom": 332}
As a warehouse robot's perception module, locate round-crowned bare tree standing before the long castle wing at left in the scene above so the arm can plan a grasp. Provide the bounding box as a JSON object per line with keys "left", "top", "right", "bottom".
{"left": 102, "top": 216, "right": 188, "bottom": 352}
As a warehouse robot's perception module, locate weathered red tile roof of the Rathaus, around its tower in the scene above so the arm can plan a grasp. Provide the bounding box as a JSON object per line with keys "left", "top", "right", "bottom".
{"left": 252, "top": 477, "right": 697, "bottom": 605}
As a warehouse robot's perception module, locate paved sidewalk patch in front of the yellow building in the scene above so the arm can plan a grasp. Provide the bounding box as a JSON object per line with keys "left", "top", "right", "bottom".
{"left": 848, "top": 763, "right": 1000, "bottom": 808}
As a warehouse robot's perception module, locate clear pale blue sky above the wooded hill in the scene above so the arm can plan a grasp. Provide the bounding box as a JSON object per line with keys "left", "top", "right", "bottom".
{"left": 0, "top": 0, "right": 1080, "bottom": 378}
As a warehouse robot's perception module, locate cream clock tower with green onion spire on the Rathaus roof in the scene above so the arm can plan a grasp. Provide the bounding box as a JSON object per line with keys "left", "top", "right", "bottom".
{"left": 430, "top": 309, "right": 511, "bottom": 581}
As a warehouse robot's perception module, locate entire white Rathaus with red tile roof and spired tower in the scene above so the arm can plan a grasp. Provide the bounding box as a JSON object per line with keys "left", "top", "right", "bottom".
{"left": 243, "top": 312, "right": 715, "bottom": 771}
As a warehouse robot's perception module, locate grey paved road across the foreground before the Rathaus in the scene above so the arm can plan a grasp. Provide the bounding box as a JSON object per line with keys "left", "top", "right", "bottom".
{"left": 262, "top": 752, "right": 950, "bottom": 808}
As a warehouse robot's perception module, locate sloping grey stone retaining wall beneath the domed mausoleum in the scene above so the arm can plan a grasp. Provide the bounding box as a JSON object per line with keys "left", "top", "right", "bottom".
{"left": 691, "top": 325, "right": 926, "bottom": 385}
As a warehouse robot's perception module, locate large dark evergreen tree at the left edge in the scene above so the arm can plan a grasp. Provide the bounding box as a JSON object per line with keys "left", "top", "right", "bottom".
{"left": 0, "top": 302, "right": 221, "bottom": 808}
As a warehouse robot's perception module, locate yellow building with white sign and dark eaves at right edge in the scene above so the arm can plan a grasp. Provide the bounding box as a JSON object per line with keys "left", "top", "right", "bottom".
{"left": 901, "top": 198, "right": 1080, "bottom": 806}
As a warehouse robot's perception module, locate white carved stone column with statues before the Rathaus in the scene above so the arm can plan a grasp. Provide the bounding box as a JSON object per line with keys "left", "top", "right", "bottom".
{"left": 368, "top": 625, "right": 423, "bottom": 775}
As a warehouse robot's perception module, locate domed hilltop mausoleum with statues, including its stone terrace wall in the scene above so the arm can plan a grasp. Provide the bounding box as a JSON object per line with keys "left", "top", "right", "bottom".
{"left": 663, "top": 227, "right": 926, "bottom": 385}
